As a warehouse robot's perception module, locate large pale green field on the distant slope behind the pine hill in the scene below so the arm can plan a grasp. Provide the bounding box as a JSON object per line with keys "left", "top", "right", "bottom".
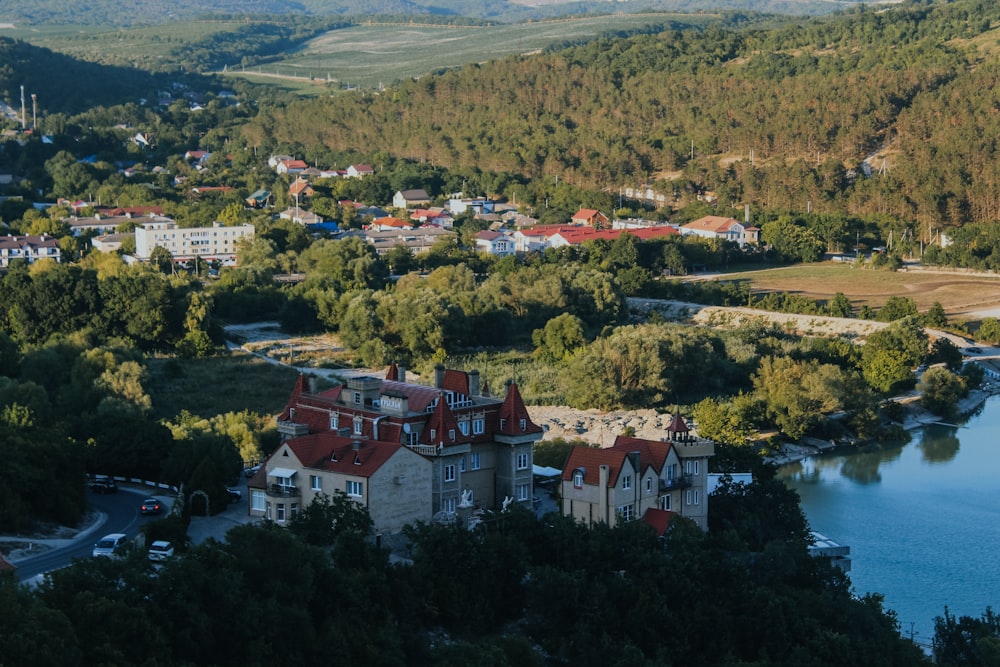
{"left": 227, "top": 13, "right": 712, "bottom": 88}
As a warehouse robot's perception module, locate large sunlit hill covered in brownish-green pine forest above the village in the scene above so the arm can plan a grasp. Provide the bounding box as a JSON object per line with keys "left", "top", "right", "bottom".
{"left": 245, "top": 1, "right": 1000, "bottom": 225}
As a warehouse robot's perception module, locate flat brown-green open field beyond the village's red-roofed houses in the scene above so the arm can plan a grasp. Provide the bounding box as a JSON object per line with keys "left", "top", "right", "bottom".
{"left": 713, "top": 262, "right": 1000, "bottom": 320}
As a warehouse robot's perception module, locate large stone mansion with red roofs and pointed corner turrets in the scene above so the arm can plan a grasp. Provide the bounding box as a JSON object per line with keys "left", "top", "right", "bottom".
{"left": 249, "top": 364, "right": 542, "bottom": 531}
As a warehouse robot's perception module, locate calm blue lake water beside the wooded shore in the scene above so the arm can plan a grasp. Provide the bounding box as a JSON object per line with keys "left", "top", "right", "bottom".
{"left": 779, "top": 397, "right": 1000, "bottom": 643}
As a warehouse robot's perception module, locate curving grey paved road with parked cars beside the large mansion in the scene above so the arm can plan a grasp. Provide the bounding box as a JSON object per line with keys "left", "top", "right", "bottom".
{"left": 15, "top": 487, "right": 157, "bottom": 581}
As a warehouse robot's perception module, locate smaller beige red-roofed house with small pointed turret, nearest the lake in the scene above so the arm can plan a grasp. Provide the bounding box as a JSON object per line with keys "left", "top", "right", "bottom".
{"left": 561, "top": 414, "right": 715, "bottom": 530}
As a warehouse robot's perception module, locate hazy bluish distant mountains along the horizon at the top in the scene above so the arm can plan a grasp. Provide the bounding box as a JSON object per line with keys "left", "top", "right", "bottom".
{"left": 0, "top": 0, "right": 876, "bottom": 26}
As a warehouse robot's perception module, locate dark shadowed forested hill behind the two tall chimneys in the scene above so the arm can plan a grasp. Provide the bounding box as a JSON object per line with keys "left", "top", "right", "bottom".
{"left": 0, "top": 37, "right": 157, "bottom": 113}
